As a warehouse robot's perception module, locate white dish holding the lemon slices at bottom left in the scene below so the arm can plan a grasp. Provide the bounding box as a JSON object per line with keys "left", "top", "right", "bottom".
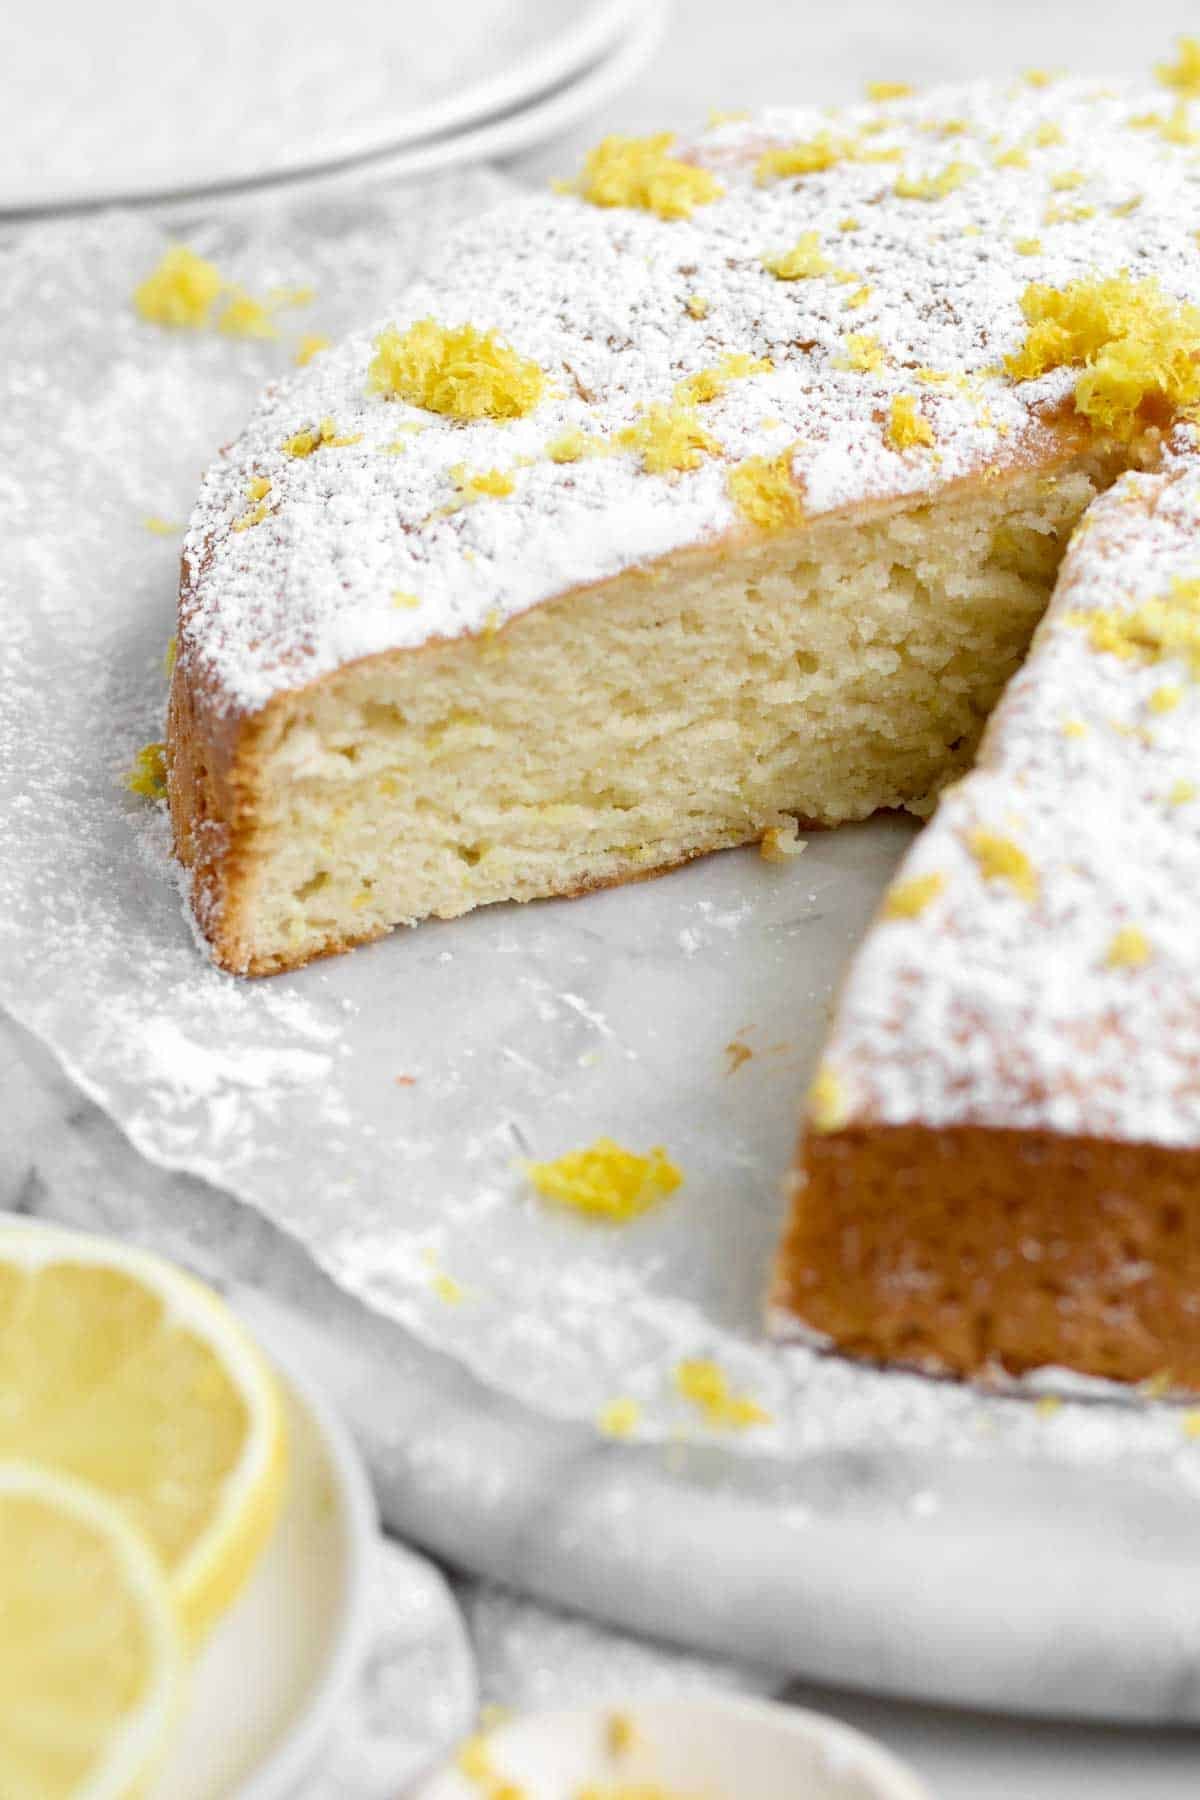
{"left": 146, "top": 1345, "right": 378, "bottom": 1800}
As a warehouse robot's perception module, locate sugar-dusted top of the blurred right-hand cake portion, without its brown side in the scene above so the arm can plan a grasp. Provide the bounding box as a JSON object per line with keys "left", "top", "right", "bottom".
{"left": 810, "top": 430, "right": 1200, "bottom": 1147}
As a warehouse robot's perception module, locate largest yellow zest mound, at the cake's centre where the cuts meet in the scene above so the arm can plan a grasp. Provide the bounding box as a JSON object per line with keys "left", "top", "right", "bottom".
{"left": 1004, "top": 274, "right": 1200, "bottom": 441}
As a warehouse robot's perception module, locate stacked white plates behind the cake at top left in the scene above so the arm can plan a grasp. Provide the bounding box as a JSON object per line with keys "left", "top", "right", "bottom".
{"left": 0, "top": 0, "right": 664, "bottom": 218}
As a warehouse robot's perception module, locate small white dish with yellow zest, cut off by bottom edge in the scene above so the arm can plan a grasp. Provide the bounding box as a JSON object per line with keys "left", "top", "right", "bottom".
{"left": 412, "top": 1694, "right": 930, "bottom": 1800}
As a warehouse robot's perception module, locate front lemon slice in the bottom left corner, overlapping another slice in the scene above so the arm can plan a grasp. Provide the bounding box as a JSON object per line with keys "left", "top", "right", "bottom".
{"left": 0, "top": 1463, "right": 185, "bottom": 1800}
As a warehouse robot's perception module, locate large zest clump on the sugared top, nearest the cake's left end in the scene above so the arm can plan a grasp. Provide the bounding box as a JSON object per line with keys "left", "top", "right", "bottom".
{"left": 367, "top": 319, "right": 545, "bottom": 419}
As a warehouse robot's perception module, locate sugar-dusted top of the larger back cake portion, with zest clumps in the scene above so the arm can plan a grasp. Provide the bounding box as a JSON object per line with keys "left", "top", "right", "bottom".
{"left": 180, "top": 70, "right": 1200, "bottom": 713}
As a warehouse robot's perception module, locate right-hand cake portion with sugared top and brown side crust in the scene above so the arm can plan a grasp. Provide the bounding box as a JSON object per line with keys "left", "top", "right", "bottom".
{"left": 775, "top": 448, "right": 1200, "bottom": 1388}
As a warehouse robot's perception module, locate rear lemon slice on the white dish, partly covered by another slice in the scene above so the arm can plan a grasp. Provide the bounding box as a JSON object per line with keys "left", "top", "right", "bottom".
{"left": 0, "top": 1224, "right": 286, "bottom": 1636}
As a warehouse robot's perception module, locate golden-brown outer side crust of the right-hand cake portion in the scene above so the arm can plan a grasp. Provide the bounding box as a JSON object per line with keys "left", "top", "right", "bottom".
{"left": 774, "top": 1125, "right": 1200, "bottom": 1390}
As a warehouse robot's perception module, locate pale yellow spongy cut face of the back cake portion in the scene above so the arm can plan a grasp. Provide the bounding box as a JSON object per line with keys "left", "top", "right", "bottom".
{"left": 230, "top": 457, "right": 1108, "bottom": 972}
